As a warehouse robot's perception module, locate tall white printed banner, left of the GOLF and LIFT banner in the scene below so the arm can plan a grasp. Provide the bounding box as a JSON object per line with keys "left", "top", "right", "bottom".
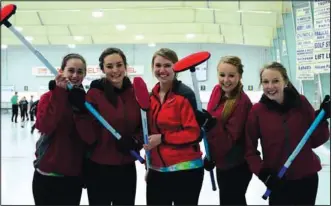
{"left": 295, "top": 2, "right": 314, "bottom": 80}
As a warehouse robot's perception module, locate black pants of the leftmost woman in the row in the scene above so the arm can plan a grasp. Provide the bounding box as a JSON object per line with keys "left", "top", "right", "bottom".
{"left": 32, "top": 171, "right": 82, "bottom": 205}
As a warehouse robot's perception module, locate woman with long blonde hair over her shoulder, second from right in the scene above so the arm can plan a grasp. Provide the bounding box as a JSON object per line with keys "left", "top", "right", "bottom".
{"left": 204, "top": 56, "right": 252, "bottom": 205}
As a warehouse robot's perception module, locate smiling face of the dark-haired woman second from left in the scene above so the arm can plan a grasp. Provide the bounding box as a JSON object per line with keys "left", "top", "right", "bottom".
{"left": 103, "top": 53, "right": 126, "bottom": 88}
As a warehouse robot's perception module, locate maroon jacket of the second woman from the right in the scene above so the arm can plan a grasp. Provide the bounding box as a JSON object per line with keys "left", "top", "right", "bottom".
{"left": 207, "top": 85, "right": 252, "bottom": 170}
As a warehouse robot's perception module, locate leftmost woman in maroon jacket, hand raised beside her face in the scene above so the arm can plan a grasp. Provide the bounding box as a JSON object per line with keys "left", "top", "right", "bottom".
{"left": 32, "top": 54, "right": 95, "bottom": 205}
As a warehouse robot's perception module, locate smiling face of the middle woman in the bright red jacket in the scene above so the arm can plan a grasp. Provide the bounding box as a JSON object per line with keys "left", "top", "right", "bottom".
{"left": 152, "top": 55, "right": 175, "bottom": 84}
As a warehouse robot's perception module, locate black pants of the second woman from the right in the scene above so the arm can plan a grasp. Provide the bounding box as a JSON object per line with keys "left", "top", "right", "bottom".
{"left": 217, "top": 163, "right": 252, "bottom": 205}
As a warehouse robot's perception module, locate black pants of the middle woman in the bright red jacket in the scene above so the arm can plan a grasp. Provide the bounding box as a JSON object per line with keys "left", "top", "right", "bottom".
{"left": 146, "top": 168, "right": 204, "bottom": 205}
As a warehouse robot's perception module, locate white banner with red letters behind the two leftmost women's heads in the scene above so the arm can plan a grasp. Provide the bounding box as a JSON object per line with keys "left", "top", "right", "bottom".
{"left": 32, "top": 65, "right": 144, "bottom": 77}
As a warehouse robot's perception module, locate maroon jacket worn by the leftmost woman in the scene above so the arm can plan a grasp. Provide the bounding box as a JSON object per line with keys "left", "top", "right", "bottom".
{"left": 36, "top": 87, "right": 95, "bottom": 176}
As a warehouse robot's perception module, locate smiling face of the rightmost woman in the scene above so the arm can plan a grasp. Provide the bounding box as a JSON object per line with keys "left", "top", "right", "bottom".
{"left": 261, "top": 68, "right": 286, "bottom": 104}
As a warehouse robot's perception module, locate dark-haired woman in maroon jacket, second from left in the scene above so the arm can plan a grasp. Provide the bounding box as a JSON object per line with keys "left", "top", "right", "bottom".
{"left": 85, "top": 48, "right": 143, "bottom": 205}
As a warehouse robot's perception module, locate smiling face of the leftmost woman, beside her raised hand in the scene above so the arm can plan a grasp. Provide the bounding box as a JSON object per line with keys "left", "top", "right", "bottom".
{"left": 63, "top": 58, "right": 86, "bottom": 86}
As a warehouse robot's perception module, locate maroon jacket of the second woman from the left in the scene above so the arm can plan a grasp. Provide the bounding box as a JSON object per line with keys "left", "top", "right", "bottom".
{"left": 86, "top": 78, "right": 143, "bottom": 165}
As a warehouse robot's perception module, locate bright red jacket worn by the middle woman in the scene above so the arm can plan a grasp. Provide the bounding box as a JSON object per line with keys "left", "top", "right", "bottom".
{"left": 148, "top": 80, "right": 202, "bottom": 167}
